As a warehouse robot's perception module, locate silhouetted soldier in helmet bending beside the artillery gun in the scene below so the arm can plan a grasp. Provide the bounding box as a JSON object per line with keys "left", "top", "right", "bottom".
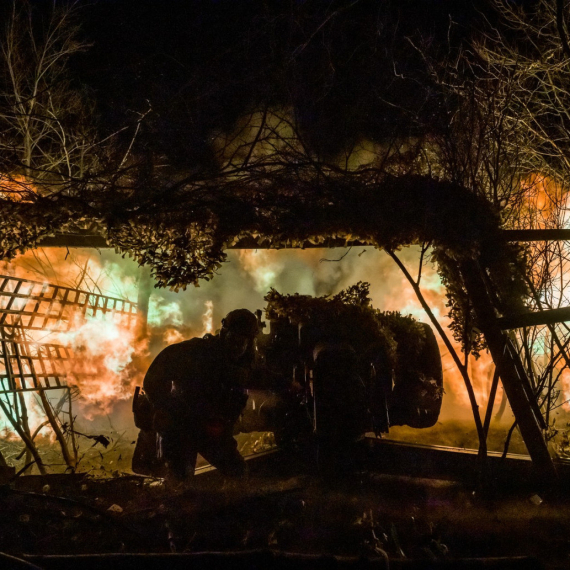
{"left": 143, "top": 309, "right": 258, "bottom": 481}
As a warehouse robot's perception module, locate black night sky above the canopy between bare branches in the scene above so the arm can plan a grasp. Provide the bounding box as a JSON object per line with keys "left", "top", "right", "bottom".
{"left": 51, "top": 0, "right": 483, "bottom": 169}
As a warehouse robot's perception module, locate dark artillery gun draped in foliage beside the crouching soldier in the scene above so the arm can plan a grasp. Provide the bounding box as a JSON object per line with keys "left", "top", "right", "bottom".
{"left": 133, "top": 283, "right": 443, "bottom": 474}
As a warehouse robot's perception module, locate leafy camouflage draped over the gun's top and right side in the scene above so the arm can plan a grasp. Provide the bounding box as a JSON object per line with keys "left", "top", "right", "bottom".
{"left": 265, "top": 281, "right": 443, "bottom": 427}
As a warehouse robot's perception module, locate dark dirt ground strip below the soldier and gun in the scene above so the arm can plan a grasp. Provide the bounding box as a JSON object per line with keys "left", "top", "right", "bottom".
{"left": 0, "top": 444, "right": 570, "bottom": 569}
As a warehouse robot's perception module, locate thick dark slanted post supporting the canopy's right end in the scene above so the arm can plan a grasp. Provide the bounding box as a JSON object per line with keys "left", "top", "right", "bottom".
{"left": 461, "top": 261, "right": 557, "bottom": 485}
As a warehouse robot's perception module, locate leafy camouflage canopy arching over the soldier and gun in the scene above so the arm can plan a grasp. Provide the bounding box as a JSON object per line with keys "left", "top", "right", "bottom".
{"left": 0, "top": 171, "right": 526, "bottom": 352}
